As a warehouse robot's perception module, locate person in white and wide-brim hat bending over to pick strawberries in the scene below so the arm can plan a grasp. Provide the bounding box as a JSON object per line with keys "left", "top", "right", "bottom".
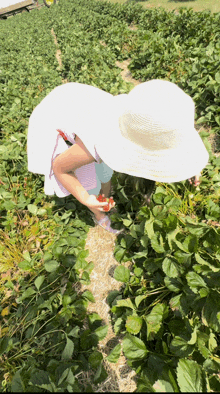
{"left": 27, "top": 80, "right": 209, "bottom": 234}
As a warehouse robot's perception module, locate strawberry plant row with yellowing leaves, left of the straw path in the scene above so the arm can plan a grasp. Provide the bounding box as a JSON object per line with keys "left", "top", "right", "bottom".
{"left": 0, "top": 3, "right": 113, "bottom": 392}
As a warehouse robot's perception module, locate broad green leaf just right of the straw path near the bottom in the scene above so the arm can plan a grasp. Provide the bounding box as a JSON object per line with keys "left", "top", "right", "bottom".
{"left": 122, "top": 334, "right": 148, "bottom": 360}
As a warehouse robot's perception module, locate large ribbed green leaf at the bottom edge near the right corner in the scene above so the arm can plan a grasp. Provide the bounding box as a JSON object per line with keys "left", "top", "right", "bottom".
{"left": 177, "top": 359, "right": 207, "bottom": 393}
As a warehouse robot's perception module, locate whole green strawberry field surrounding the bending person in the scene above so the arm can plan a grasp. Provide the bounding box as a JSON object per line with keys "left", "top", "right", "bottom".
{"left": 0, "top": 0, "right": 220, "bottom": 392}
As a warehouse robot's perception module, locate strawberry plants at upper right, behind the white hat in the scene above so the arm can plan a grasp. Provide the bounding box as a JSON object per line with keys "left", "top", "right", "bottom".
{"left": 129, "top": 8, "right": 220, "bottom": 133}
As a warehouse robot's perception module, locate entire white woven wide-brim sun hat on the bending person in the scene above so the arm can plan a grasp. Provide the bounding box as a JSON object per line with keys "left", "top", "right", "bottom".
{"left": 95, "top": 79, "right": 209, "bottom": 183}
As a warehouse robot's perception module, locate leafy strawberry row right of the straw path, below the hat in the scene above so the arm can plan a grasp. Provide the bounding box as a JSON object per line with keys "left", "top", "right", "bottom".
{"left": 108, "top": 169, "right": 220, "bottom": 392}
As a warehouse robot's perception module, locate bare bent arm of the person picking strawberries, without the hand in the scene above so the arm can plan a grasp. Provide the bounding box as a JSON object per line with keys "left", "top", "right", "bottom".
{"left": 53, "top": 138, "right": 95, "bottom": 205}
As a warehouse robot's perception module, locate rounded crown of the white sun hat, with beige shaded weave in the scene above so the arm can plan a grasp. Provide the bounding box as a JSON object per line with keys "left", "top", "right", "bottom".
{"left": 119, "top": 80, "right": 195, "bottom": 151}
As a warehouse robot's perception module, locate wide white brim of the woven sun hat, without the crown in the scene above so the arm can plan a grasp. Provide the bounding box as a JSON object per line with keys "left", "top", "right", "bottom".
{"left": 95, "top": 91, "right": 209, "bottom": 183}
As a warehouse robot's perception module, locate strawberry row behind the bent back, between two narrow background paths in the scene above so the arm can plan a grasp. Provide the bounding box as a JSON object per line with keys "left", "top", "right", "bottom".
{"left": 46, "top": 2, "right": 136, "bottom": 89}
